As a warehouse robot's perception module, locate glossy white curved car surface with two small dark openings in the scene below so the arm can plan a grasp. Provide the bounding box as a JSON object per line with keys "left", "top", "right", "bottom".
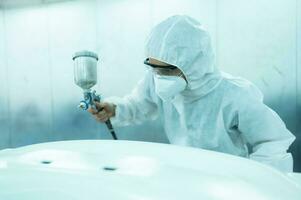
{"left": 0, "top": 141, "right": 301, "bottom": 200}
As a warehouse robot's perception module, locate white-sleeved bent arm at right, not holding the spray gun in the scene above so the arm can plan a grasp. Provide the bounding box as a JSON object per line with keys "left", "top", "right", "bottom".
{"left": 238, "top": 85, "right": 295, "bottom": 172}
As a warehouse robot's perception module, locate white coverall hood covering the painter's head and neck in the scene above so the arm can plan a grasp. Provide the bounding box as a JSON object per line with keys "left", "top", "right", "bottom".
{"left": 146, "top": 15, "right": 221, "bottom": 102}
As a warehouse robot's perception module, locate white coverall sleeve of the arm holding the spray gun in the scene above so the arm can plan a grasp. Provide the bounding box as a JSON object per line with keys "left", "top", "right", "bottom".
{"left": 105, "top": 72, "right": 158, "bottom": 126}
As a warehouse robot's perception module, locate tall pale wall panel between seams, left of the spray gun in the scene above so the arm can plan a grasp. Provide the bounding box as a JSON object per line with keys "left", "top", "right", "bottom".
{"left": 5, "top": 7, "right": 51, "bottom": 147}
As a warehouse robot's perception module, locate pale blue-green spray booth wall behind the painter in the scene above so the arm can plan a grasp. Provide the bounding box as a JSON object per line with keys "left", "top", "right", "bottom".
{"left": 0, "top": 0, "right": 301, "bottom": 171}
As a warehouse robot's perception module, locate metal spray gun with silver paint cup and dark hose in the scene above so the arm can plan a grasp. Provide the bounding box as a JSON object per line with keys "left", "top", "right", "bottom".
{"left": 72, "top": 51, "right": 117, "bottom": 140}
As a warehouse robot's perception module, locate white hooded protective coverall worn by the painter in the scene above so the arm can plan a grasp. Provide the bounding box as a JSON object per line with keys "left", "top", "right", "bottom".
{"left": 109, "top": 15, "right": 295, "bottom": 171}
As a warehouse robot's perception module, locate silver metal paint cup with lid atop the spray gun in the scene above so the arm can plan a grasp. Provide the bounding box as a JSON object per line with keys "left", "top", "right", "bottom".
{"left": 73, "top": 51, "right": 98, "bottom": 91}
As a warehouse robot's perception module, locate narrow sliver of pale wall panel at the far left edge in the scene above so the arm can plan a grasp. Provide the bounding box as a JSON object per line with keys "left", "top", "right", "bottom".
{"left": 0, "top": 8, "right": 10, "bottom": 149}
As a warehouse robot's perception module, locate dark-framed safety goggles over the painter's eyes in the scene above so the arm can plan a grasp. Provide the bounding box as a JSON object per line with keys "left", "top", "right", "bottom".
{"left": 144, "top": 58, "right": 182, "bottom": 76}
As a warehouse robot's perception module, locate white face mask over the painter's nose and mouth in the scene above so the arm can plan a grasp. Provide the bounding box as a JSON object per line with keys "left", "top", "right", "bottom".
{"left": 154, "top": 74, "right": 187, "bottom": 101}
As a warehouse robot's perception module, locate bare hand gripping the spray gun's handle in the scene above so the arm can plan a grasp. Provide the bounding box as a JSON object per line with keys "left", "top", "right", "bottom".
{"left": 88, "top": 102, "right": 116, "bottom": 122}
